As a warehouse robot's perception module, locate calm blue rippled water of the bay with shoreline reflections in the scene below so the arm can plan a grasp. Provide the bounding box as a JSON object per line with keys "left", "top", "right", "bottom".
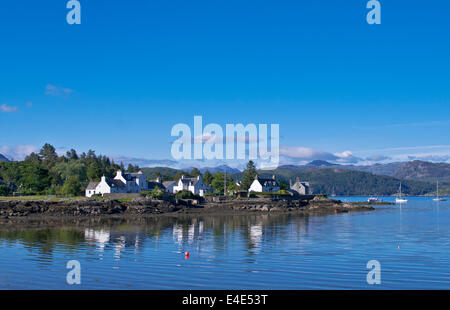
{"left": 0, "top": 197, "right": 450, "bottom": 289}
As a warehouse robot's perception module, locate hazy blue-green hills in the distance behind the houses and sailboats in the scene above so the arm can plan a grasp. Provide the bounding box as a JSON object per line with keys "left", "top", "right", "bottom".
{"left": 143, "top": 160, "right": 450, "bottom": 195}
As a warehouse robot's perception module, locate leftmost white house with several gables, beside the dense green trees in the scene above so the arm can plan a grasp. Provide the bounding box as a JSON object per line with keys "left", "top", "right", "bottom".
{"left": 86, "top": 170, "right": 148, "bottom": 197}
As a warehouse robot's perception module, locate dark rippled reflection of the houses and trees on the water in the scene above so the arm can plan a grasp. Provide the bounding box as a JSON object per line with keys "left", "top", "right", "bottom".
{"left": 0, "top": 214, "right": 309, "bottom": 257}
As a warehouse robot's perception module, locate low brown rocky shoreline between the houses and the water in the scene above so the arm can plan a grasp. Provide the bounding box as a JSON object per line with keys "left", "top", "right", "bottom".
{"left": 0, "top": 198, "right": 388, "bottom": 219}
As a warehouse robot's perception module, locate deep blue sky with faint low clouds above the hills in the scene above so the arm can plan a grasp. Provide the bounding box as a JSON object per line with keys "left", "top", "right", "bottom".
{"left": 0, "top": 0, "right": 450, "bottom": 168}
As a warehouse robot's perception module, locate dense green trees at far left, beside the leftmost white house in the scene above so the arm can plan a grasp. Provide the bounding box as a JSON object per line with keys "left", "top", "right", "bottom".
{"left": 0, "top": 143, "right": 139, "bottom": 196}
